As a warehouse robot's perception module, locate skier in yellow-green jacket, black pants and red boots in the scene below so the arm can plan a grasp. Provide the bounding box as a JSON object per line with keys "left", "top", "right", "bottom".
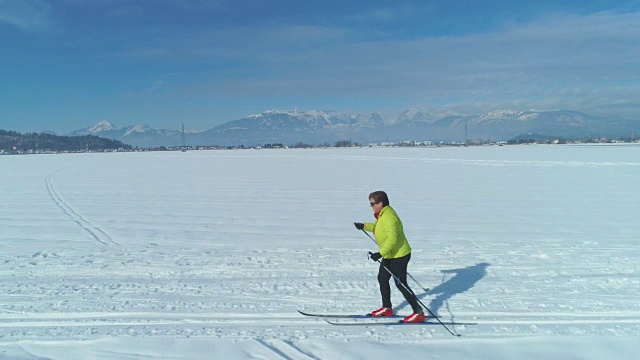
{"left": 354, "top": 191, "right": 426, "bottom": 322}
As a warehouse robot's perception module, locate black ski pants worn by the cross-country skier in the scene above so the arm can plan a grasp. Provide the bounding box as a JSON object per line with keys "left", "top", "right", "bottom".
{"left": 378, "top": 253, "right": 421, "bottom": 313}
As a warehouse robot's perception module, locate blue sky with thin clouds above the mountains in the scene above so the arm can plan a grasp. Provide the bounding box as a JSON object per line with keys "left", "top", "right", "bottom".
{"left": 0, "top": 0, "right": 640, "bottom": 133}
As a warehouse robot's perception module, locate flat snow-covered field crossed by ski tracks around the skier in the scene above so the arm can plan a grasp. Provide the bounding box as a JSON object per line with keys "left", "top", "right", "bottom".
{"left": 0, "top": 146, "right": 640, "bottom": 360}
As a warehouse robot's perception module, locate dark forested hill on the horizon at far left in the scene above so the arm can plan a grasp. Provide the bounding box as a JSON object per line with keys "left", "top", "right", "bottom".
{"left": 0, "top": 129, "right": 131, "bottom": 153}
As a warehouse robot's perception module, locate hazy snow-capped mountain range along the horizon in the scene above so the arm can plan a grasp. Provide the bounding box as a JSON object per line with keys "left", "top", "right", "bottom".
{"left": 67, "top": 110, "right": 640, "bottom": 147}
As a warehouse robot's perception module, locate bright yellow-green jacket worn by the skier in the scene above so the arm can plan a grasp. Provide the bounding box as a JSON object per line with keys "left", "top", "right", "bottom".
{"left": 364, "top": 206, "right": 411, "bottom": 259}
